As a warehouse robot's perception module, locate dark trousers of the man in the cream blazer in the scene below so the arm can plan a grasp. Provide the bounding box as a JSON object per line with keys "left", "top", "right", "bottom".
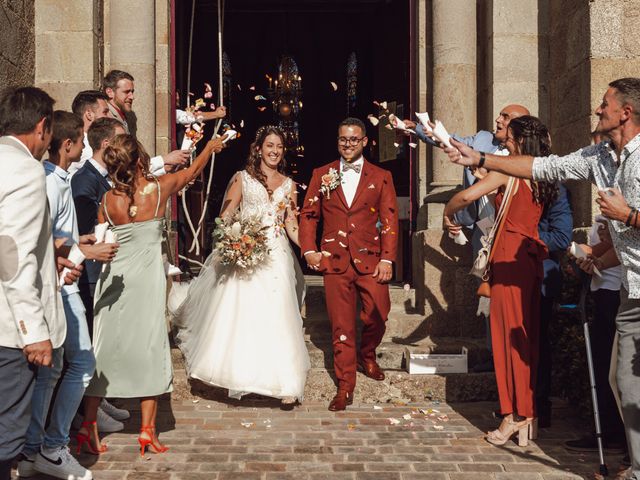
{"left": 0, "top": 347, "right": 36, "bottom": 480}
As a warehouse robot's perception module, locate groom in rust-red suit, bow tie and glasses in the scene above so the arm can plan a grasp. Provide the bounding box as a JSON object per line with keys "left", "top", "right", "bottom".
{"left": 300, "top": 118, "right": 398, "bottom": 411}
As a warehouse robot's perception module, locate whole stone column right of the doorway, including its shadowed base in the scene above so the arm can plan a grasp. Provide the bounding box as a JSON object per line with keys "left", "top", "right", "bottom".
{"left": 413, "top": 0, "right": 483, "bottom": 337}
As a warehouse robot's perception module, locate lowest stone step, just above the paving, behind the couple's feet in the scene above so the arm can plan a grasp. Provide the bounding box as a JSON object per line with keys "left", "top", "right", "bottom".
{"left": 172, "top": 368, "right": 497, "bottom": 404}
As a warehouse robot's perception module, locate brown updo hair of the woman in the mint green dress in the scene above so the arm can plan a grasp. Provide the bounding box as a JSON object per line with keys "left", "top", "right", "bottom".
{"left": 102, "top": 134, "right": 149, "bottom": 216}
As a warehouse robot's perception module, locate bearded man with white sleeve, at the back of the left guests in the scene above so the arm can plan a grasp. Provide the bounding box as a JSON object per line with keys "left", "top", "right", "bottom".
{"left": 103, "top": 70, "right": 191, "bottom": 176}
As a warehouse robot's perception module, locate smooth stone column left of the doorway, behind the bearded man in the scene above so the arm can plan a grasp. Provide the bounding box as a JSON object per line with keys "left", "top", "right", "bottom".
{"left": 106, "top": 0, "right": 156, "bottom": 154}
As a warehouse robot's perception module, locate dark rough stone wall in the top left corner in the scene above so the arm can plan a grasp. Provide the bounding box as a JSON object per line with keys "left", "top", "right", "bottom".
{"left": 0, "top": 0, "right": 36, "bottom": 89}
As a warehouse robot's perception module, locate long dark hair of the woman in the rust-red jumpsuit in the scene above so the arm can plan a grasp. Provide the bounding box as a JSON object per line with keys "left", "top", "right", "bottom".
{"left": 508, "top": 115, "right": 558, "bottom": 205}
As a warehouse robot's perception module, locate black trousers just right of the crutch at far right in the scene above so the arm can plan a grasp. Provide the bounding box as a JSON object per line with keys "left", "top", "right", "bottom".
{"left": 585, "top": 288, "right": 625, "bottom": 442}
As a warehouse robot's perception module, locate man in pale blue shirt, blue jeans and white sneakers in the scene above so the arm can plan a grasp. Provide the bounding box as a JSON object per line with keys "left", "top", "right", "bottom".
{"left": 18, "top": 110, "right": 118, "bottom": 480}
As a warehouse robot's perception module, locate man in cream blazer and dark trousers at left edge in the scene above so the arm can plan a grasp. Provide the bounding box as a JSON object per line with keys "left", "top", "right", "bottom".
{"left": 0, "top": 87, "right": 79, "bottom": 480}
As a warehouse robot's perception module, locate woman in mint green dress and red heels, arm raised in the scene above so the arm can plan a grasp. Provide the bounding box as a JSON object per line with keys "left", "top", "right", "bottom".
{"left": 78, "top": 135, "right": 223, "bottom": 454}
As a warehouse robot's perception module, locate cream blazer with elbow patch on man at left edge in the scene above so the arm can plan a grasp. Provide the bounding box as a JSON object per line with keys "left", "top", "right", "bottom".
{"left": 0, "top": 136, "right": 67, "bottom": 348}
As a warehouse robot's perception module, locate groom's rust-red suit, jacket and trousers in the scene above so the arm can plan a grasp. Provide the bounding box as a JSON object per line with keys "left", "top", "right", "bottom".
{"left": 300, "top": 160, "right": 398, "bottom": 392}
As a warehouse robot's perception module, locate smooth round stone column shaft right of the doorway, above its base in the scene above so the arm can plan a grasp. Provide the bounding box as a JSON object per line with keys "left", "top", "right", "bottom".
{"left": 431, "top": 0, "right": 476, "bottom": 189}
